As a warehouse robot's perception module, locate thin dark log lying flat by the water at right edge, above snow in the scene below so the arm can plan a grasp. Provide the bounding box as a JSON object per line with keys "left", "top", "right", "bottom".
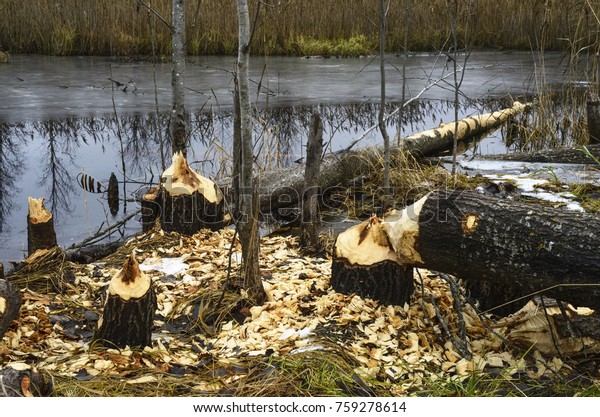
{"left": 475, "top": 144, "right": 600, "bottom": 165}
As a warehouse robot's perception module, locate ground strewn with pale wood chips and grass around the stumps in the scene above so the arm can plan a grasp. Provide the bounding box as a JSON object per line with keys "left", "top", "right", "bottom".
{"left": 0, "top": 229, "right": 600, "bottom": 396}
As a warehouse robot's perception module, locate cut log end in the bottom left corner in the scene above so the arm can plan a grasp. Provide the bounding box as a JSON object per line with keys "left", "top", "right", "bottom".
{"left": 0, "top": 367, "right": 54, "bottom": 397}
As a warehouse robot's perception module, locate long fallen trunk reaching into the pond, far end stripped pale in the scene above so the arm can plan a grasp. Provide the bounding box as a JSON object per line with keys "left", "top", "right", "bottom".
{"left": 237, "top": 102, "right": 527, "bottom": 214}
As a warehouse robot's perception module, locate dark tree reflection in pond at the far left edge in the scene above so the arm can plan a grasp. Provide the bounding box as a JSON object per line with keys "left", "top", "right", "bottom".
{"left": 0, "top": 123, "right": 24, "bottom": 232}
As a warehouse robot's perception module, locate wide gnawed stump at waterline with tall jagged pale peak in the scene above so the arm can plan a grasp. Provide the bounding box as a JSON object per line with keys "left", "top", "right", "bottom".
{"left": 156, "top": 152, "right": 224, "bottom": 235}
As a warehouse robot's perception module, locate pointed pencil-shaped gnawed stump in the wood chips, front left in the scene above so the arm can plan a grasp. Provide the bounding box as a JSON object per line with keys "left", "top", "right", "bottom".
{"left": 94, "top": 254, "right": 157, "bottom": 348}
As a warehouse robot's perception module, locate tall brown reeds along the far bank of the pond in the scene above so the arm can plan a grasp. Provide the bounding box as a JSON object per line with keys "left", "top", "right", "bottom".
{"left": 0, "top": 0, "right": 600, "bottom": 55}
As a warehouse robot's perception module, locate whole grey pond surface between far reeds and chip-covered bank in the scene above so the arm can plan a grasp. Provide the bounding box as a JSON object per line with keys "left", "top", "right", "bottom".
{"left": 0, "top": 52, "right": 592, "bottom": 262}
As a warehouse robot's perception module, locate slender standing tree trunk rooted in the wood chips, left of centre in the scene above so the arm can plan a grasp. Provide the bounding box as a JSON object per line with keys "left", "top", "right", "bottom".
{"left": 237, "top": 0, "right": 266, "bottom": 304}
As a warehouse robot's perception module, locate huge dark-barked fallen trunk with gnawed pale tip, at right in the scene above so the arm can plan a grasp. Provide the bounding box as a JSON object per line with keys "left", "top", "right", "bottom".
{"left": 382, "top": 190, "right": 600, "bottom": 313}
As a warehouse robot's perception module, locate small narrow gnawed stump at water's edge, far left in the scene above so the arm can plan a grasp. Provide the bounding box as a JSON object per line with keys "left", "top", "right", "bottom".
{"left": 27, "top": 197, "right": 57, "bottom": 256}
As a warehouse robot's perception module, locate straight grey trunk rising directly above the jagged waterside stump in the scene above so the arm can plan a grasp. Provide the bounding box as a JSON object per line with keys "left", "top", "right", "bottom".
{"left": 171, "top": 0, "right": 187, "bottom": 156}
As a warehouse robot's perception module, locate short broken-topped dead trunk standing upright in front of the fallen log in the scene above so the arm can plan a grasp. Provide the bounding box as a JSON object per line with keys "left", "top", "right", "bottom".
{"left": 300, "top": 113, "right": 323, "bottom": 253}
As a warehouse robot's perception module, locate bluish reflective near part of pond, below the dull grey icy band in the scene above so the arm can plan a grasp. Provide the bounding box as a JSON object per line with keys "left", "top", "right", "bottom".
{"left": 0, "top": 96, "right": 568, "bottom": 261}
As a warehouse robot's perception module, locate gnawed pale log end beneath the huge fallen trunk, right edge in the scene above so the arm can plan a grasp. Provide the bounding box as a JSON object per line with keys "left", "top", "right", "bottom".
{"left": 494, "top": 297, "right": 600, "bottom": 357}
